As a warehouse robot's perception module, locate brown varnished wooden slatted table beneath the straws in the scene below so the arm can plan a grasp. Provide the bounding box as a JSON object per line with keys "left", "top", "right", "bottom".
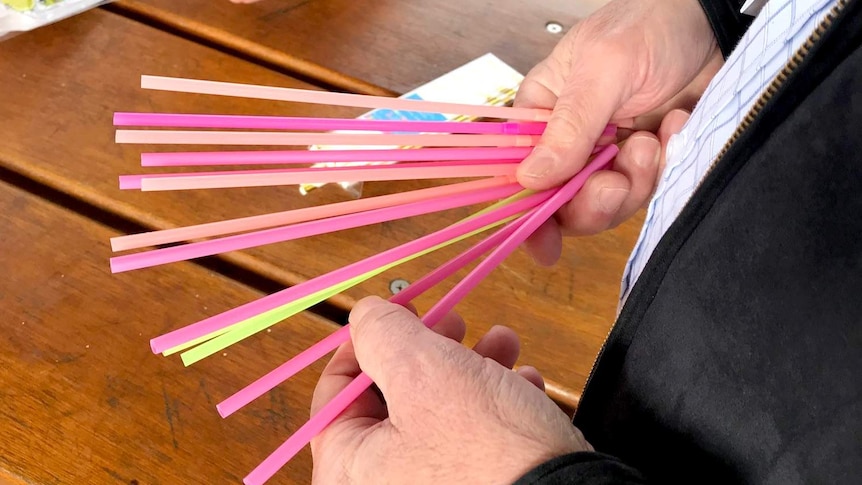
{"left": 0, "top": 0, "right": 638, "bottom": 483}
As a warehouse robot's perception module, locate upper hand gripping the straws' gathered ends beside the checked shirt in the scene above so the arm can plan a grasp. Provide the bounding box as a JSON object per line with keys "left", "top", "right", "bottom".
{"left": 515, "top": 0, "right": 723, "bottom": 264}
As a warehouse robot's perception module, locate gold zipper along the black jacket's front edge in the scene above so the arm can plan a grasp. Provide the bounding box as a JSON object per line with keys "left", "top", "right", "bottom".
{"left": 580, "top": 0, "right": 850, "bottom": 397}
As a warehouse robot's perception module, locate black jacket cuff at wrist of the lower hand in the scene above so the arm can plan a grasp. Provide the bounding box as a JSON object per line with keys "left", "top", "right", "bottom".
{"left": 515, "top": 452, "right": 646, "bottom": 485}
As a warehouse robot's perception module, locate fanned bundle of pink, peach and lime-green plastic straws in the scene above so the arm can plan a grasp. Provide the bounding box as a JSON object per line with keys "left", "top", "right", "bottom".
{"left": 111, "top": 76, "right": 618, "bottom": 485}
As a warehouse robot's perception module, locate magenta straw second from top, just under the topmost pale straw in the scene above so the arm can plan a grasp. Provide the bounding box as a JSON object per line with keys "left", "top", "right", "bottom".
{"left": 114, "top": 113, "right": 547, "bottom": 135}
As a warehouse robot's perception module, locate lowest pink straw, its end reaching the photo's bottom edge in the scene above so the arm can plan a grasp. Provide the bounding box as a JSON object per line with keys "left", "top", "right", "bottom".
{"left": 243, "top": 145, "right": 619, "bottom": 485}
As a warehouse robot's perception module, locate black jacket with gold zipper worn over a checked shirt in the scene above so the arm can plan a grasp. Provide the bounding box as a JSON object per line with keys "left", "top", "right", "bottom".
{"left": 518, "top": 0, "right": 862, "bottom": 485}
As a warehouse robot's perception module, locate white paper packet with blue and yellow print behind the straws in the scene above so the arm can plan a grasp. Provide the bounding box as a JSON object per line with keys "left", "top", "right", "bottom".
{"left": 299, "top": 54, "right": 524, "bottom": 198}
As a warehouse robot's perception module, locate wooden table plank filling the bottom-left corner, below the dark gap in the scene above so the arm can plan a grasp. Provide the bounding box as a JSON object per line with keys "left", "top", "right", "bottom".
{"left": 0, "top": 182, "right": 335, "bottom": 484}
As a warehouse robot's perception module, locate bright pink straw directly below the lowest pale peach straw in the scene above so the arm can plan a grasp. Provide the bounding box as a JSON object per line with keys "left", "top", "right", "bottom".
{"left": 111, "top": 184, "right": 522, "bottom": 273}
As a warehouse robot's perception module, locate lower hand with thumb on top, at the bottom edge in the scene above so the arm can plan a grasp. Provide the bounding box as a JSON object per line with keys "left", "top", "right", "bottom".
{"left": 311, "top": 297, "right": 592, "bottom": 484}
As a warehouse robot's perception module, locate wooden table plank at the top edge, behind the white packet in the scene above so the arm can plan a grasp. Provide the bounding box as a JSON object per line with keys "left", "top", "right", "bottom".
{"left": 111, "top": 0, "right": 604, "bottom": 94}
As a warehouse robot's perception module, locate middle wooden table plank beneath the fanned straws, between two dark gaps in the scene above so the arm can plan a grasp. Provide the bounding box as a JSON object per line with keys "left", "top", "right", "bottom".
{"left": 0, "top": 11, "right": 638, "bottom": 400}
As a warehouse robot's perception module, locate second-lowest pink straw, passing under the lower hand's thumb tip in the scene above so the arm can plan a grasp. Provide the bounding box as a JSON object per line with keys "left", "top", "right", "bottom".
{"left": 216, "top": 217, "right": 524, "bottom": 418}
